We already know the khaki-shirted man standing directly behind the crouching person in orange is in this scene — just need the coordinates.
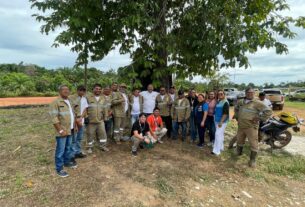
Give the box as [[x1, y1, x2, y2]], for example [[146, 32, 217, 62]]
[[156, 86, 173, 138]]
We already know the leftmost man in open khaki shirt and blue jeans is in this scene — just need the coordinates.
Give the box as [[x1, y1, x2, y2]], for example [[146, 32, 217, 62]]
[[49, 85, 79, 177]]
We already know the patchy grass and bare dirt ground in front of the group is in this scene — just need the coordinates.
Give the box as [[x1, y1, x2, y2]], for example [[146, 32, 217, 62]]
[[0, 108, 305, 207]]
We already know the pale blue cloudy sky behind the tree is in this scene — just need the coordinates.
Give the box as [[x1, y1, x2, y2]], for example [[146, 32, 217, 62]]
[[0, 0, 305, 84]]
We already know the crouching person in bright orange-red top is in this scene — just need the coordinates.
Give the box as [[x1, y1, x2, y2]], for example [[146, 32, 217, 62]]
[[147, 107, 167, 143]]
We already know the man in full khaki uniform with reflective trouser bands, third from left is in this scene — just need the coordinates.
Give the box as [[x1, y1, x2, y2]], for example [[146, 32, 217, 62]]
[[87, 84, 109, 153]]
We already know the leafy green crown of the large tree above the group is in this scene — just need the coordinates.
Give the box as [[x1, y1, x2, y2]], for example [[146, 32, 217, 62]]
[[30, 0, 305, 86]]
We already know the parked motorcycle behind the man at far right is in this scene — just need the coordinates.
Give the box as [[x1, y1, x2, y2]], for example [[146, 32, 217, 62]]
[[259, 112, 304, 149]]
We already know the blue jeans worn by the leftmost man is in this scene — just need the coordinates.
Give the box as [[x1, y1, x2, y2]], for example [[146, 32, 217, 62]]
[[55, 135, 73, 172]]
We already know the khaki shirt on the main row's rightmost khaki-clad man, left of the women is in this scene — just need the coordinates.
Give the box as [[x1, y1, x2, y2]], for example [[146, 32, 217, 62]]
[[171, 98, 191, 122]]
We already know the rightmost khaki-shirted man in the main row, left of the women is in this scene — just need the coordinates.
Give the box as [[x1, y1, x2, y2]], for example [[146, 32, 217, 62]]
[[171, 90, 191, 141]]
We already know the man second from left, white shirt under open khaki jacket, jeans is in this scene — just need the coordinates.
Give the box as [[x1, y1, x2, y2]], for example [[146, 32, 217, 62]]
[[69, 86, 88, 158]]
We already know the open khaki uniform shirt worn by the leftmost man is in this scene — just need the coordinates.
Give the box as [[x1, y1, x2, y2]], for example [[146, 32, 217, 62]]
[[49, 97, 77, 137]]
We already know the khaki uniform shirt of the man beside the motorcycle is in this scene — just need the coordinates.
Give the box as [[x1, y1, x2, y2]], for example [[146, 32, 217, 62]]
[[234, 99, 272, 129]]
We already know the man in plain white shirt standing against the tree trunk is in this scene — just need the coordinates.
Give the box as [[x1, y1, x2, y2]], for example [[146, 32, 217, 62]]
[[140, 84, 159, 116]]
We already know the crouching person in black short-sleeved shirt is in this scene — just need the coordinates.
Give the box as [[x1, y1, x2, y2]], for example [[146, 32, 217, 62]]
[[131, 113, 156, 156]]
